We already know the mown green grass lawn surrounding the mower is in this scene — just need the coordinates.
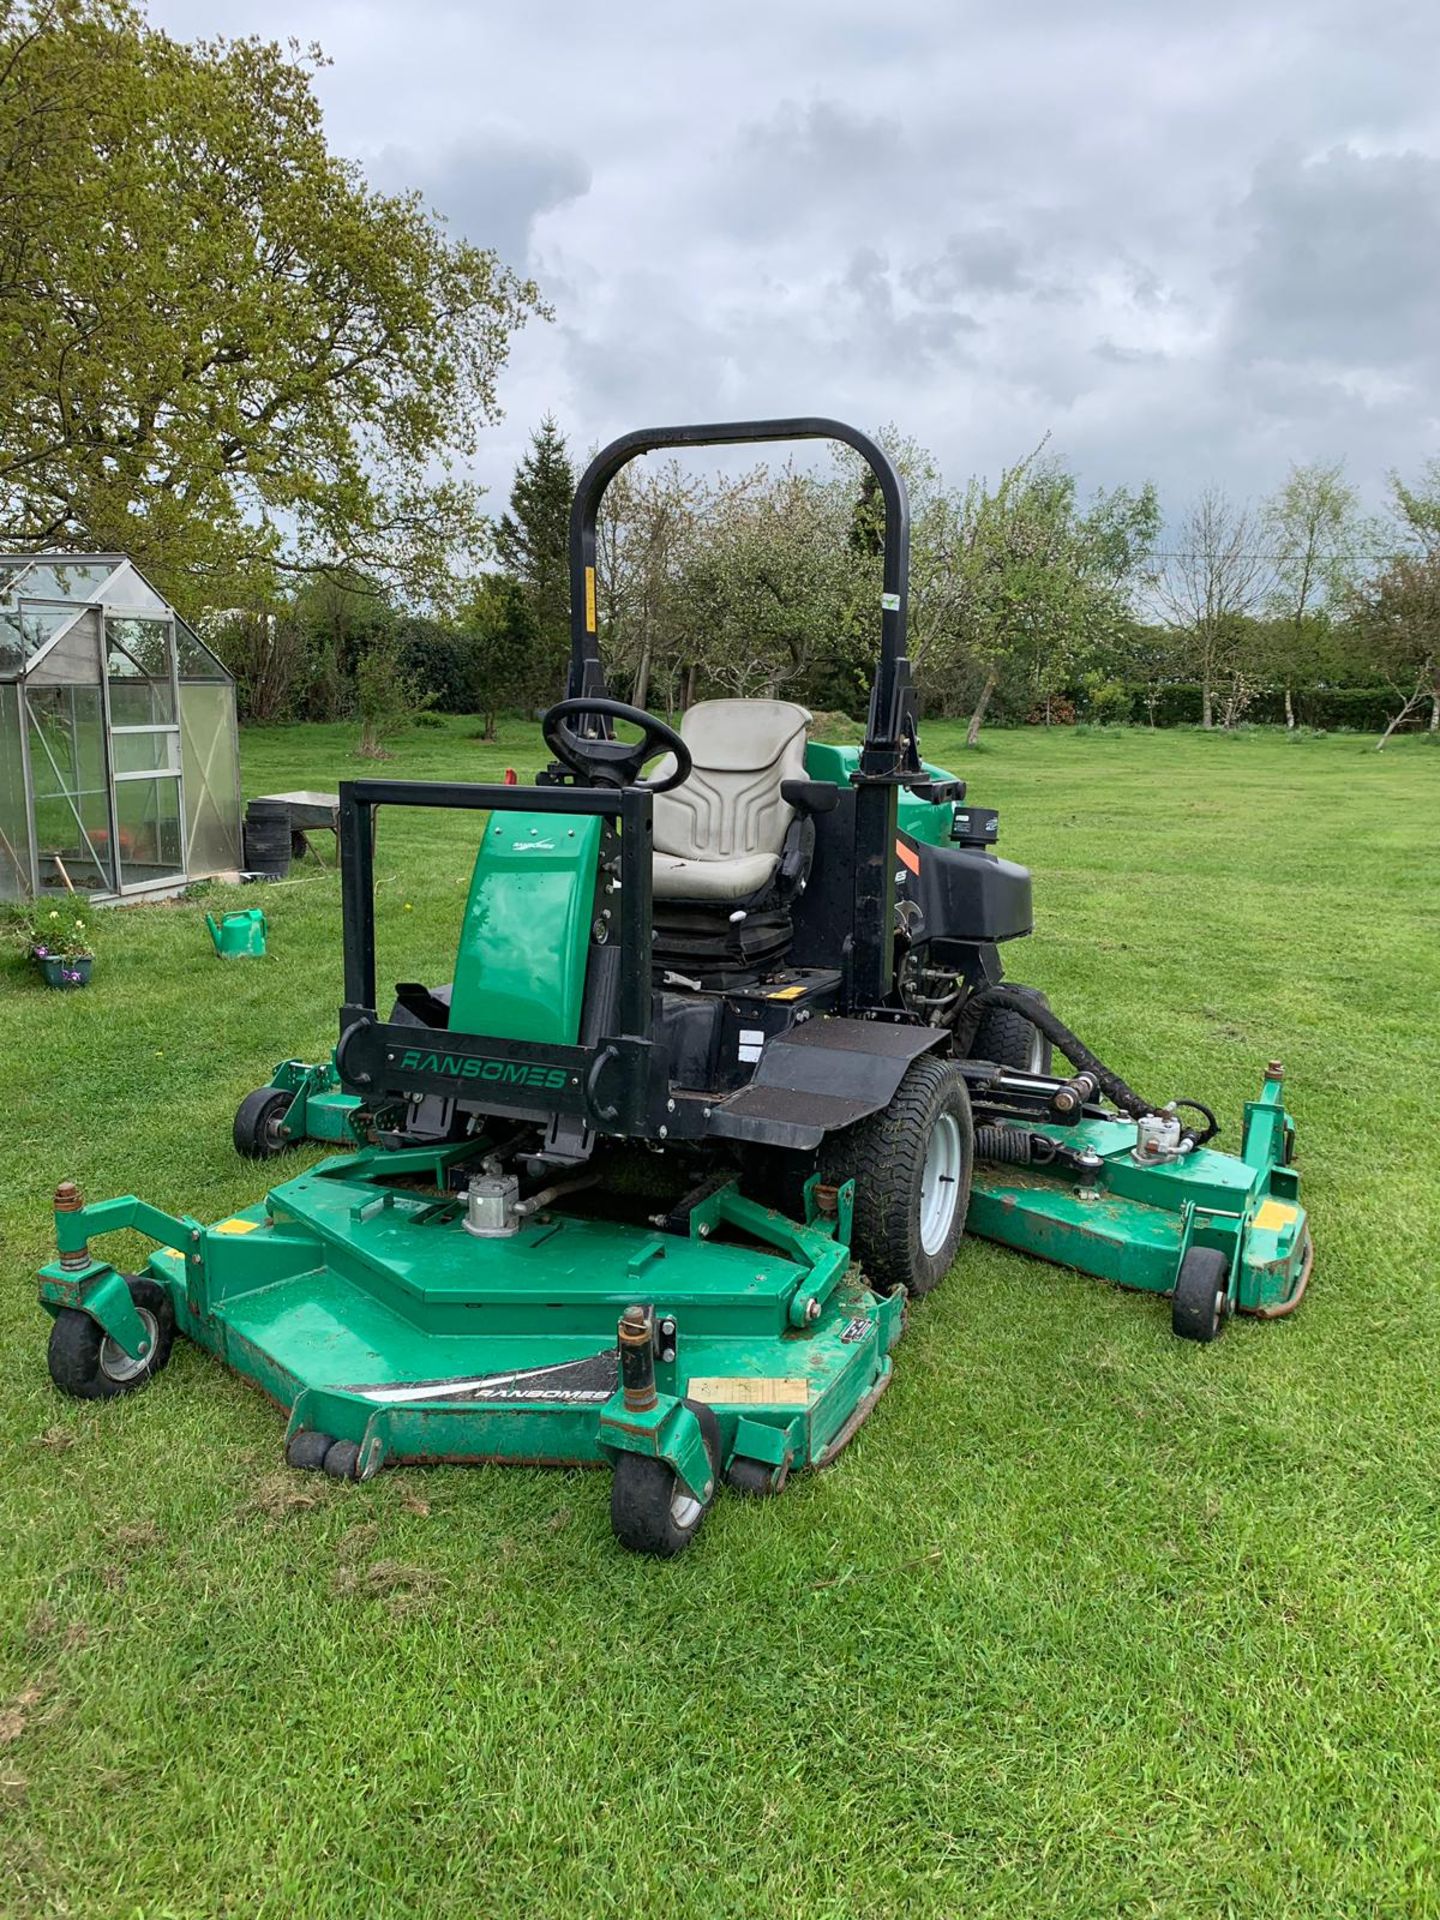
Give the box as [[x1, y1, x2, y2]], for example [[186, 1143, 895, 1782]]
[[0, 722, 1440, 1920]]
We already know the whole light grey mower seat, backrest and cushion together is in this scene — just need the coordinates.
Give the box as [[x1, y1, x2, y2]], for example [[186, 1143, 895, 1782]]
[[655, 701, 810, 900]]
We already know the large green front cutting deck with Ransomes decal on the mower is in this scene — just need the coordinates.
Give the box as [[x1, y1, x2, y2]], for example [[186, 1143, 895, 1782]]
[[40, 1148, 902, 1501]]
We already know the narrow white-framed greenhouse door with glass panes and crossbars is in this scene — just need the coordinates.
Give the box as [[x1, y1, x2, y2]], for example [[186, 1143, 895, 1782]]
[[106, 616, 186, 893]]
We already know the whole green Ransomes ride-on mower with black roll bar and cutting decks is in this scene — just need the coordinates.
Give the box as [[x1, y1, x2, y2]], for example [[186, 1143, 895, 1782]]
[[40, 419, 1309, 1555]]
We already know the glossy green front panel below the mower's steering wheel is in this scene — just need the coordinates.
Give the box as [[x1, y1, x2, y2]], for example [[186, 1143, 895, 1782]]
[[449, 812, 601, 1046]]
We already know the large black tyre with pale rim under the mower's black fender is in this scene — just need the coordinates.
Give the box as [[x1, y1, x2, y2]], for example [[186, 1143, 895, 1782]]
[[822, 1054, 975, 1294]]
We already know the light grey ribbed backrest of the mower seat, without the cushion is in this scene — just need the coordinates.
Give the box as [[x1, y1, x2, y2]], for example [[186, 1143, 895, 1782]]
[[655, 701, 810, 860]]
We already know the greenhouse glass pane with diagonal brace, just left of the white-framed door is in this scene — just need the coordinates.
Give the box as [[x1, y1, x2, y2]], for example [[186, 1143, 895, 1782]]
[[25, 687, 115, 893]]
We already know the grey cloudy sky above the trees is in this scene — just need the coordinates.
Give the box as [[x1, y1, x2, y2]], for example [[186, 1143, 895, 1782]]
[[150, 0, 1440, 513]]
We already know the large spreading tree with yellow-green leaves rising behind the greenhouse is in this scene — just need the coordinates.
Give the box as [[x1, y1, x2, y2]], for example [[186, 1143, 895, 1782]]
[[0, 0, 538, 605]]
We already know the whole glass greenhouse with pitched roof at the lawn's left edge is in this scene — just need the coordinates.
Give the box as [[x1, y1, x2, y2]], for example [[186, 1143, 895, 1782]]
[[0, 553, 240, 900]]
